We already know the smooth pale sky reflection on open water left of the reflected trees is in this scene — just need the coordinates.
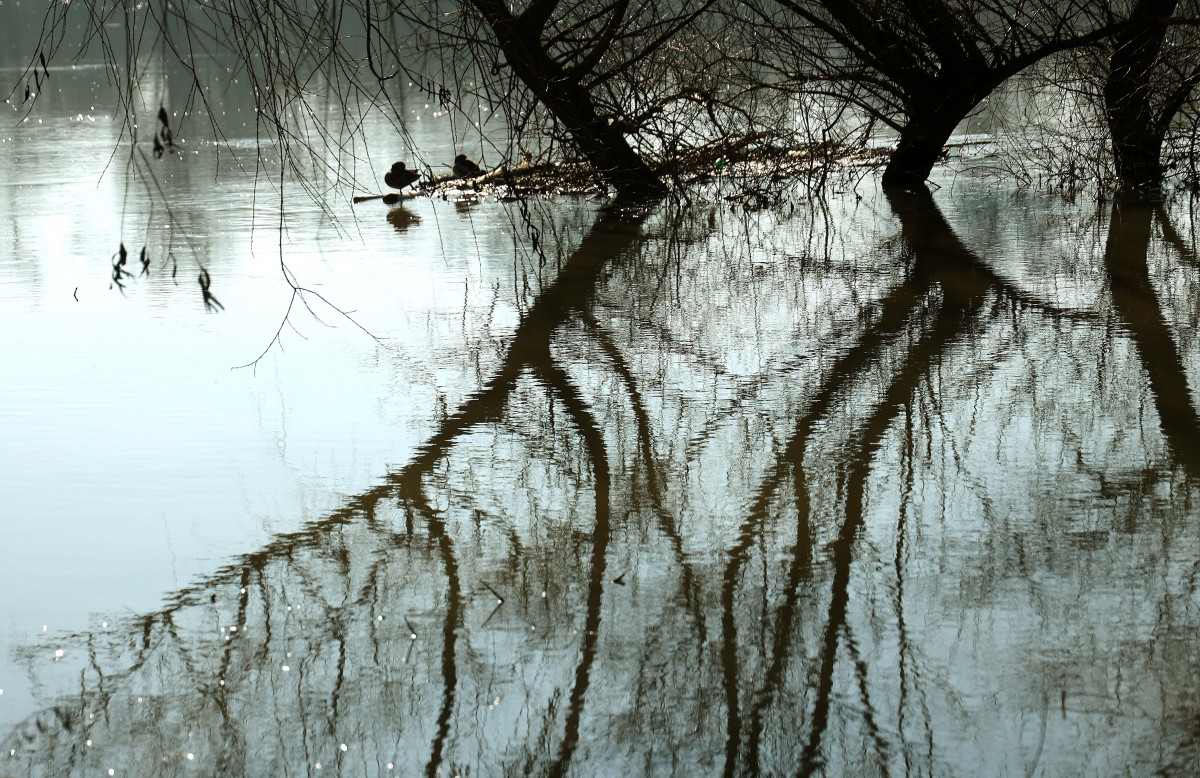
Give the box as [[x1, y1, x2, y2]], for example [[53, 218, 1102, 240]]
[[0, 60, 530, 730]]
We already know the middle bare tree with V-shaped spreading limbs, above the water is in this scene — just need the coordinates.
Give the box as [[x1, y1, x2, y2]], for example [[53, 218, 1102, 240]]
[[750, 0, 1147, 186]]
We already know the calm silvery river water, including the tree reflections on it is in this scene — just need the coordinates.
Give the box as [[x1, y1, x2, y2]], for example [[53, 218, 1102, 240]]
[[0, 47, 1200, 776]]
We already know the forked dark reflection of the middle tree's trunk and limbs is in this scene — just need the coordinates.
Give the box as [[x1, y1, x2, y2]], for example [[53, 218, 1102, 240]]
[[722, 187, 1099, 776]]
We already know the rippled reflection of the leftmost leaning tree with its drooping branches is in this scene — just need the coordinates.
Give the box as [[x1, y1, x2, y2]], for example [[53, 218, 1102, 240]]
[[2, 201, 690, 776]]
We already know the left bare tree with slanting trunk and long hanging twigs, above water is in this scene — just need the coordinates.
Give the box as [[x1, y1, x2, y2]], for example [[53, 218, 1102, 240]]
[[18, 0, 825, 198]]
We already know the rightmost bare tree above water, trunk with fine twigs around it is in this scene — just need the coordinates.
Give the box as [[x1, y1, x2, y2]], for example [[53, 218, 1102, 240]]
[[988, 0, 1200, 194]]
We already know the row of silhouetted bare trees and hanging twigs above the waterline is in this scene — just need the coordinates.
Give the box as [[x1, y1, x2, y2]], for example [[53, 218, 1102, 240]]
[[17, 0, 1200, 198]]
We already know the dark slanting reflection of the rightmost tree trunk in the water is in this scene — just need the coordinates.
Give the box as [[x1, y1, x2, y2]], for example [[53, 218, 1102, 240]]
[[1104, 202, 1200, 478]]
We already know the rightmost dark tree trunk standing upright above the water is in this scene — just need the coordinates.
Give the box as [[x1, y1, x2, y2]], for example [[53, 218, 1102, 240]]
[[1104, 0, 1177, 198]]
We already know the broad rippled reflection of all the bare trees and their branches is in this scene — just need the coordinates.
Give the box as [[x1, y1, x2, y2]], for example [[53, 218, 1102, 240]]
[[0, 184, 1200, 776]]
